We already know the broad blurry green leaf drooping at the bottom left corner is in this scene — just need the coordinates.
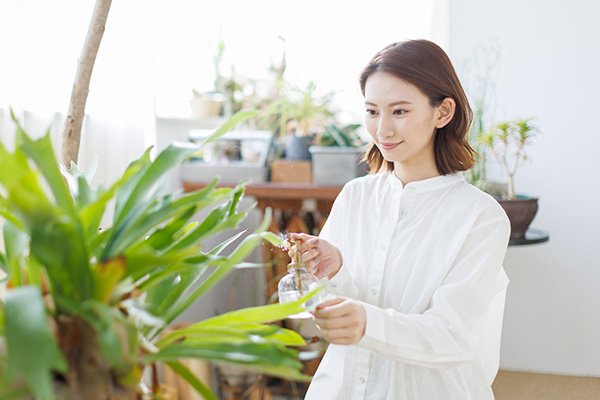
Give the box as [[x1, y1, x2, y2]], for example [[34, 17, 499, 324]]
[[5, 286, 67, 400]]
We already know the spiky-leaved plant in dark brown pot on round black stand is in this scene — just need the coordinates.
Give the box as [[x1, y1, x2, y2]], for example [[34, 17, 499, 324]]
[[479, 118, 539, 239]]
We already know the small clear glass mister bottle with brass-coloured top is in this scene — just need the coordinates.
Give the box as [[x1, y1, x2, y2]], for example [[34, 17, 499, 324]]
[[278, 241, 325, 318]]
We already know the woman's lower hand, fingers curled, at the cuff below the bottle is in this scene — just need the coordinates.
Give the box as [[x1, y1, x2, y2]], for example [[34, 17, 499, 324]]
[[313, 297, 367, 344]]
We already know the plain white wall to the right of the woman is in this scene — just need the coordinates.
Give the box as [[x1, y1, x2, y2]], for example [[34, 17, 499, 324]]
[[450, 0, 600, 376]]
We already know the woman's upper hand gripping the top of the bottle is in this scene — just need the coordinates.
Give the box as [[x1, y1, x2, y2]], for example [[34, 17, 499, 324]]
[[288, 233, 342, 279]]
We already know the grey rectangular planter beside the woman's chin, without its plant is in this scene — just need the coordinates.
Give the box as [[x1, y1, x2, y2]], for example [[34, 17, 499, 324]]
[[309, 146, 367, 186]]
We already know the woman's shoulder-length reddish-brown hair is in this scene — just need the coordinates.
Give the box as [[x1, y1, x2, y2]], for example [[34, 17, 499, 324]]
[[360, 40, 477, 175]]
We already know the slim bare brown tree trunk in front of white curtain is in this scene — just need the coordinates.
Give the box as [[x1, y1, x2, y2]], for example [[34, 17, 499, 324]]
[[60, 0, 112, 168]]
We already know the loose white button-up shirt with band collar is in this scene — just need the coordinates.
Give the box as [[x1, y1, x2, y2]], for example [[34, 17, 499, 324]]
[[306, 172, 510, 400]]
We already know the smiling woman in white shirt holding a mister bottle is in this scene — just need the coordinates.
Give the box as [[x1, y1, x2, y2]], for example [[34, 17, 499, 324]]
[[293, 40, 510, 400]]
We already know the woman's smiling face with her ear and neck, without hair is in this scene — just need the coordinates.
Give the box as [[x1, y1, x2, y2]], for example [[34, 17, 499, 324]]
[[365, 72, 445, 177]]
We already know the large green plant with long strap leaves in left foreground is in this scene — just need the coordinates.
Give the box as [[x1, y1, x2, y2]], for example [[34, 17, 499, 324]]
[[0, 112, 316, 400]]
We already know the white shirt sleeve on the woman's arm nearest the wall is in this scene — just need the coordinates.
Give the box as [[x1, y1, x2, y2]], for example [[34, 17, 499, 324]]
[[357, 215, 510, 367]]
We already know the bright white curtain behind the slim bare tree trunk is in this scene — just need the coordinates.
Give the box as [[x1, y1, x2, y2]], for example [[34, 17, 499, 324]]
[[0, 0, 155, 185]]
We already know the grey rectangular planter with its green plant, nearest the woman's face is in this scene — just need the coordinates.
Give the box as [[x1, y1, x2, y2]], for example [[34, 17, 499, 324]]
[[309, 123, 367, 185]]
